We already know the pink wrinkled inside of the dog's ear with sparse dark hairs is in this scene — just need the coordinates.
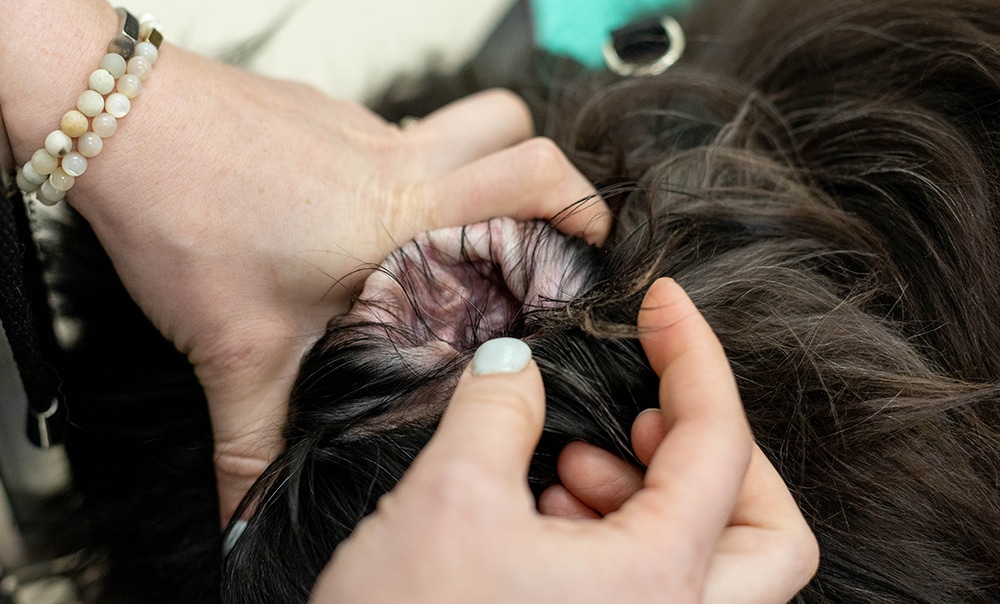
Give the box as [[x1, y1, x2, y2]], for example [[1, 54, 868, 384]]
[[351, 218, 593, 351]]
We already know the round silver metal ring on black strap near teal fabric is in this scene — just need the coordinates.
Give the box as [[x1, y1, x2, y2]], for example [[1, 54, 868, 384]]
[[604, 17, 687, 77]]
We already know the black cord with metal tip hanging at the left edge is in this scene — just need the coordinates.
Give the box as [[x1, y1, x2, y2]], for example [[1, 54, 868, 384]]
[[0, 177, 65, 448]]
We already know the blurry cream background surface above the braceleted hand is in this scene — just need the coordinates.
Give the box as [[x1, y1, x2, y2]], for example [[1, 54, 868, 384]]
[[142, 0, 513, 99]]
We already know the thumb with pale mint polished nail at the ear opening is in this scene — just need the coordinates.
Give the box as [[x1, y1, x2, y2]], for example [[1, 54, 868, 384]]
[[420, 338, 545, 485]]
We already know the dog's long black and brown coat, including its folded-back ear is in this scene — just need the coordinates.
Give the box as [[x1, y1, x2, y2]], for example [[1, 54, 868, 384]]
[[222, 0, 1000, 603]]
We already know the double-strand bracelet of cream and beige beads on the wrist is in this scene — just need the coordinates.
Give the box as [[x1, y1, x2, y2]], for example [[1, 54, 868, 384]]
[[17, 8, 163, 205]]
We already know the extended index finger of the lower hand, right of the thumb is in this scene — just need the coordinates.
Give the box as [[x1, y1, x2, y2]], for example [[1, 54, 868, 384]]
[[622, 279, 753, 552]]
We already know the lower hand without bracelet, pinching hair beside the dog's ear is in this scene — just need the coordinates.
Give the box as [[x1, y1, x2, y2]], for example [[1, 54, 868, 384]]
[[313, 280, 818, 604]]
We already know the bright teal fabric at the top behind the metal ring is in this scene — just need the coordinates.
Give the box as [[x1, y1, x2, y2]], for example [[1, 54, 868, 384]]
[[531, 0, 692, 67]]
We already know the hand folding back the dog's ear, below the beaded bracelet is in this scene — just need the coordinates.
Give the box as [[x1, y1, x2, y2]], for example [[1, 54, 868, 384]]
[[101, 55, 609, 520]]
